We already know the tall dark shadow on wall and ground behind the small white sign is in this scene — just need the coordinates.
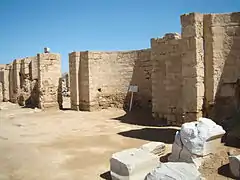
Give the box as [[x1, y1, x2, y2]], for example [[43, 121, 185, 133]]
[[111, 49, 157, 126]]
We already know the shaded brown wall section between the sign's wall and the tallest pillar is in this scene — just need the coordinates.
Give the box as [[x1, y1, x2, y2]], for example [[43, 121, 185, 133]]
[[151, 34, 182, 124]]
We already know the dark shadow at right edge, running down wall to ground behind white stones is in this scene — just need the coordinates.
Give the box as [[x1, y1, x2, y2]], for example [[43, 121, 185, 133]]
[[206, 13, 240, 147]]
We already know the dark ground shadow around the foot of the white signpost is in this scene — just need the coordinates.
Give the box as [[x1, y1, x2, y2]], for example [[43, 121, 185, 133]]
[[112, 109, 171, 127]]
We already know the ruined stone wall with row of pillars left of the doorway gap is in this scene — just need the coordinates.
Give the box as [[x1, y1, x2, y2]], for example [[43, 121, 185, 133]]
[[0, 53, 61, 109]]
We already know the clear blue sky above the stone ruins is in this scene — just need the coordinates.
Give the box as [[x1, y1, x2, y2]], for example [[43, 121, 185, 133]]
[[0, 0, 240, 72]]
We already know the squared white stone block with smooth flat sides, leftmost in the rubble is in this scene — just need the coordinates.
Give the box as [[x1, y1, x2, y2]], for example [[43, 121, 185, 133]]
[[110, 148, 160, 180]]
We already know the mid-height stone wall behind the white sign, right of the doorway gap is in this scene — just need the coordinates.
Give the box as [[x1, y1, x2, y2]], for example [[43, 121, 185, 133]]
[[69, 49, 152, 110]]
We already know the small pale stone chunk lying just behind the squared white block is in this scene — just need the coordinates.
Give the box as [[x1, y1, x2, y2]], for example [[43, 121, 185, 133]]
[[140, 142, 166, 156]]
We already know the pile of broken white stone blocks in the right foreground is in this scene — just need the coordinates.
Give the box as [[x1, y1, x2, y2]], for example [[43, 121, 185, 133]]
[[110, 118, 228, 180]]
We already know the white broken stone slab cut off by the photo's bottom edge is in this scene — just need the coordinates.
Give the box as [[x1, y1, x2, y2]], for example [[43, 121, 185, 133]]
[[145, 162, 202, 180]]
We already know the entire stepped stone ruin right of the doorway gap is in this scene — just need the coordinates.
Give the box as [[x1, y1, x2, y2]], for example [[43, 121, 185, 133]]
[[69, 13, 240, 125]]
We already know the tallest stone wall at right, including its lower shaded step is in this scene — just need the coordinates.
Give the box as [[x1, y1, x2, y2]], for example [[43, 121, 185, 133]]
[[151, 13, 240, 124]]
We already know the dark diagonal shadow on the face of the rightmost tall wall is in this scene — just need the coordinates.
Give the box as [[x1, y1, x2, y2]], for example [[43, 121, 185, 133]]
[[207, 13, 240, 123]]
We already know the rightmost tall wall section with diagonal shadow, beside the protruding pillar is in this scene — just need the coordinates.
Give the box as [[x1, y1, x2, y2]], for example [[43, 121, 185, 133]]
[[204, 13, 240, 121]]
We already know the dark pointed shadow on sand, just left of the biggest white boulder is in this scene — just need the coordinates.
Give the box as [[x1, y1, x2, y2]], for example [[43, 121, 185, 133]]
[[118, 128, 177, 144]]
